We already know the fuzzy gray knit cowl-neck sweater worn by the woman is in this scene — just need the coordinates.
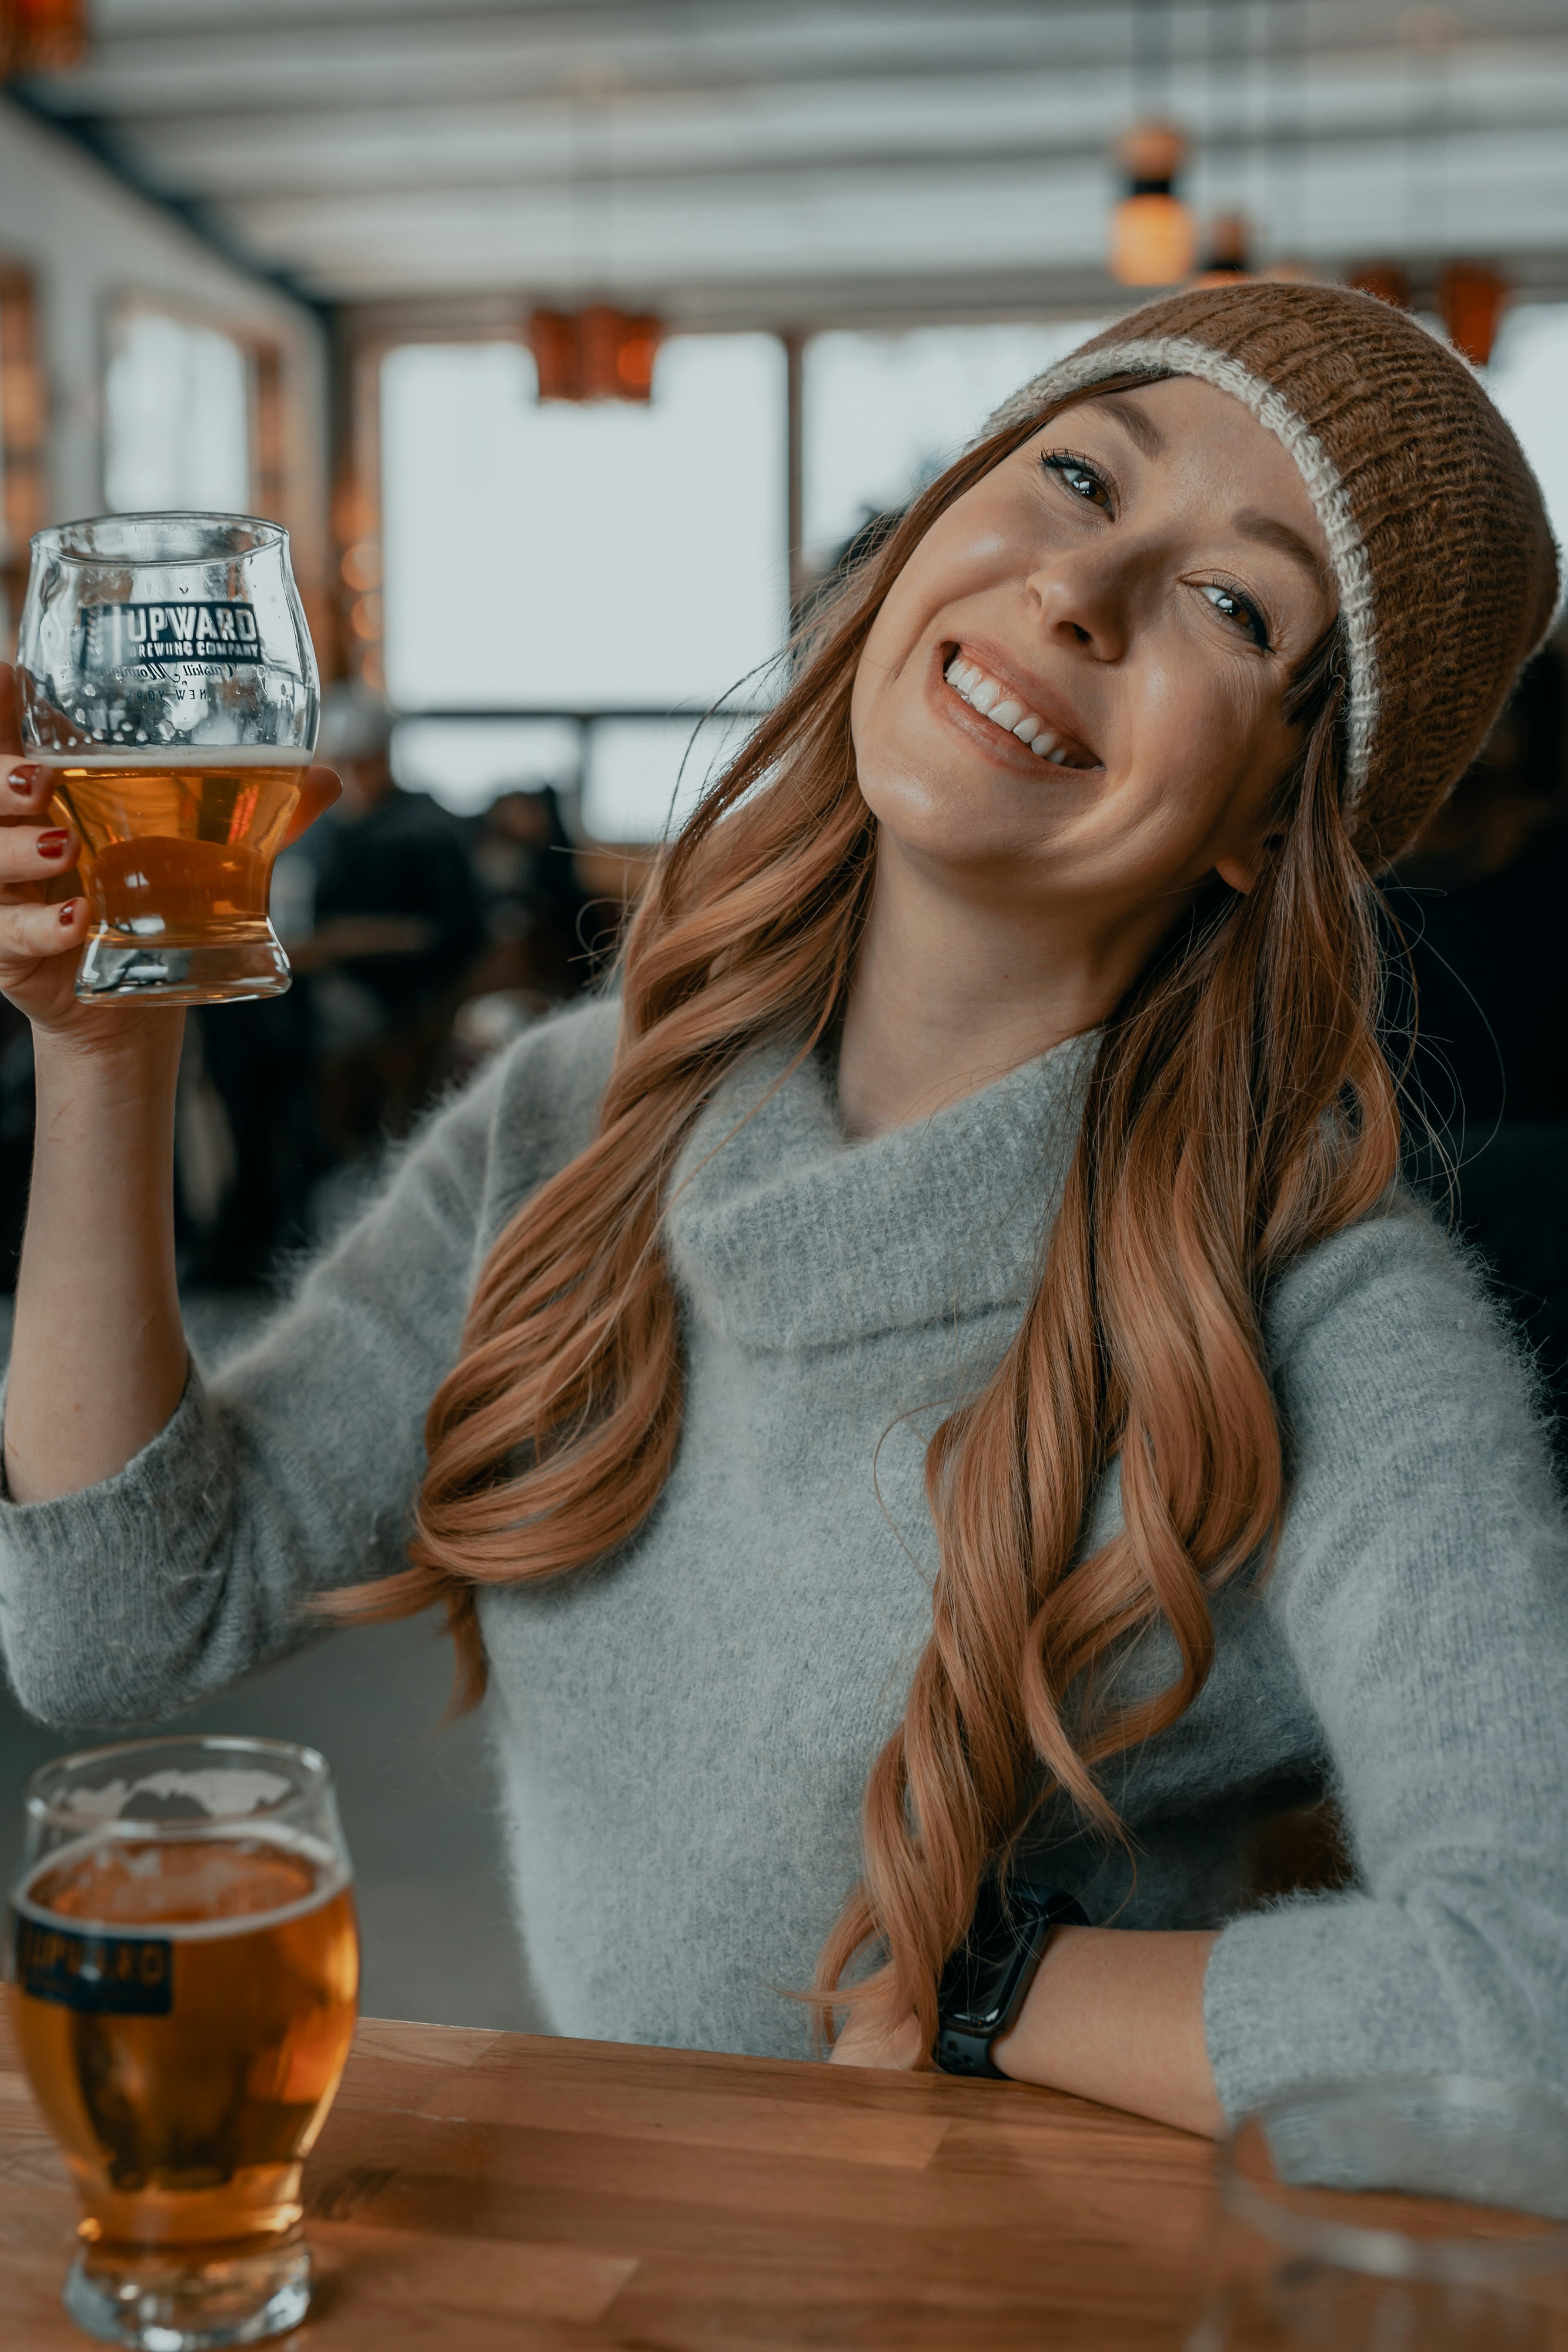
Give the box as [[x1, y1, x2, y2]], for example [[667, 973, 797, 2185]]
[[0, 1007, 1568, 2112]]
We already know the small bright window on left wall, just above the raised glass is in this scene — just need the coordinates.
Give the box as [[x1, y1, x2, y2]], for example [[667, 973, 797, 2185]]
[[103, 308, 252, 513]]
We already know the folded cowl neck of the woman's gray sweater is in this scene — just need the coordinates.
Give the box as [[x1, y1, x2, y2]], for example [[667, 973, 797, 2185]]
[[666, 1030, 1098, 1348]]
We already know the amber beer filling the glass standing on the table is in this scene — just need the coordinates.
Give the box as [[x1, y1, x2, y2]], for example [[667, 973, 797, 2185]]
[[9, 1825, 360, 2263]]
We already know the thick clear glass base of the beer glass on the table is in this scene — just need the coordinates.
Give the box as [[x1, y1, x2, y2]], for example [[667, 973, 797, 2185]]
[[63, 2230, 310, 2352]]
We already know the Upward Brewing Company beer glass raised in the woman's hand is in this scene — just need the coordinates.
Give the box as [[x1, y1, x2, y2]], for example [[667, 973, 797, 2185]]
[[16, 515, 320, 1004]]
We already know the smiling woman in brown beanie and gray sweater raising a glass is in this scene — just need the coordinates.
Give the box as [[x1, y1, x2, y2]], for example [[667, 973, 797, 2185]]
[[0, 287, 1568, 2131]]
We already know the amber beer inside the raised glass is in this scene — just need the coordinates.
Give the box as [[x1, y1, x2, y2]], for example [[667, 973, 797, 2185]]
[[54, 748, 306, 950]]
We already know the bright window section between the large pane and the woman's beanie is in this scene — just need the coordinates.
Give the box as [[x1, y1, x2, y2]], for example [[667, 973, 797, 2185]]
[[801, 320, 1093, 572]]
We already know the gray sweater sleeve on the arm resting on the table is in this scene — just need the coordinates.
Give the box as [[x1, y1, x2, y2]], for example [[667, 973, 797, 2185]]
[[1203, 1209, 1568, 2117]]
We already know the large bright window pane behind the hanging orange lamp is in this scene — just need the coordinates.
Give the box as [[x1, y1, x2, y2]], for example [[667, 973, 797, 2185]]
[[381, 334, 787, 715]]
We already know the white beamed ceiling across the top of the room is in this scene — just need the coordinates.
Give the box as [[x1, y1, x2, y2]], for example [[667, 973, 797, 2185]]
[[21, 0, 1568, 325]]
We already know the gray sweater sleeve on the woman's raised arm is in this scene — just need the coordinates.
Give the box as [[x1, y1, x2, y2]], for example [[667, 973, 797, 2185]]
[[0, 1007, 607, 1726]]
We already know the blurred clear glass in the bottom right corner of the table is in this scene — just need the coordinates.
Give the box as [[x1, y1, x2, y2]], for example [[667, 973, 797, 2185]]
[[1187, 2074, 1568, 2352]]
